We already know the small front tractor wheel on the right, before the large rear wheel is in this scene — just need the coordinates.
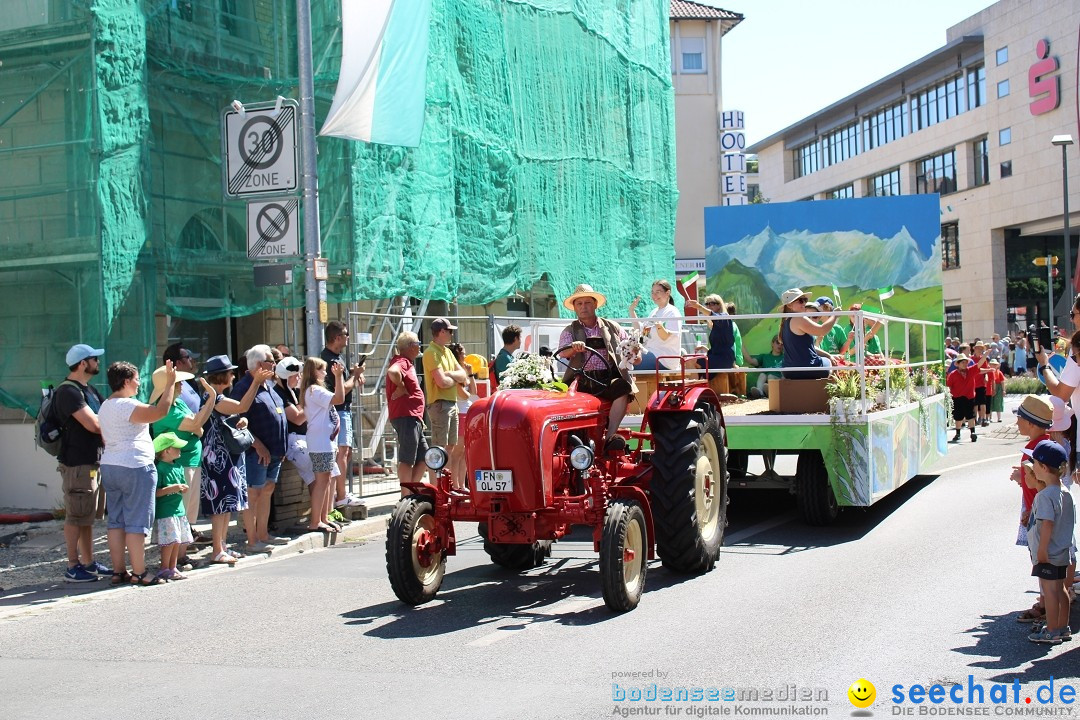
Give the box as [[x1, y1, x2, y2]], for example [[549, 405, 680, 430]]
[[600, 500, 649, 612]]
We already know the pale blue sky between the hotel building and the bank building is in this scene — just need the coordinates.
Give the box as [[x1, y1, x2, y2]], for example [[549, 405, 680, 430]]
[[712, 0, 994, 146]]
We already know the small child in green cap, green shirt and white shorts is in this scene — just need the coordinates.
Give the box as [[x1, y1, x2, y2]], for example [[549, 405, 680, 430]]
[[153, 432, 191, 582]]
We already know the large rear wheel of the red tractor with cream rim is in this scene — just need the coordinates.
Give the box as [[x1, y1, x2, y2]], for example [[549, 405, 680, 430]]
[[649, 403, 728, 572]]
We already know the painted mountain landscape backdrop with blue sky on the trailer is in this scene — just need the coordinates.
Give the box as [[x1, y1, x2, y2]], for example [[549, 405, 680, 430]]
[[705, 195, 944, 359]]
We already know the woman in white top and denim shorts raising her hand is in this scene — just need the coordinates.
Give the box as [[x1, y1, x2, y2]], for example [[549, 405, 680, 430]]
[[97, 361, 176, 585]]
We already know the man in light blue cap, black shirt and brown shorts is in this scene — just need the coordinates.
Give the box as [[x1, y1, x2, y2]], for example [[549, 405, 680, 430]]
[[50, 344, 111, 583]]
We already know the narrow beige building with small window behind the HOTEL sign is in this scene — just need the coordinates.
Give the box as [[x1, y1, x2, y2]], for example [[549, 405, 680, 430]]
[[671, 0, 743, 269]]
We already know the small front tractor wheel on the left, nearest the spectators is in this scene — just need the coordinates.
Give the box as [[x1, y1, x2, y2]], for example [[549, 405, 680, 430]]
[[387, 495, 446, 606]]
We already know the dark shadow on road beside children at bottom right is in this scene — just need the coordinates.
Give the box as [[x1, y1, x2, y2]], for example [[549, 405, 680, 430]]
[[954, 603, 1080, 683]]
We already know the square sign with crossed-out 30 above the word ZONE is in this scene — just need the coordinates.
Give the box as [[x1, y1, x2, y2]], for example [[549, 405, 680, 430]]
[[221, 100, 298, 198]]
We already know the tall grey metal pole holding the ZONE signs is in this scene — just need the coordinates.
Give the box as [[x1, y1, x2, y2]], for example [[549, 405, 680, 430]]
[[296, 0, 326, 357]]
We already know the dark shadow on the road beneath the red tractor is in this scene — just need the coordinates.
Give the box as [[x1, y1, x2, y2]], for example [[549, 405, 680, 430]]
[[341, 528, 712, 640]]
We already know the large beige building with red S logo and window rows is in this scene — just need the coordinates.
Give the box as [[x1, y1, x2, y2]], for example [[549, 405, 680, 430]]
[[748, 0, 1080, 339]]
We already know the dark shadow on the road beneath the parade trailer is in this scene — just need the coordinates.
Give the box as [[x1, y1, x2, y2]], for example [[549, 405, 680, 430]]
[[724, 475, 939, 555]]
